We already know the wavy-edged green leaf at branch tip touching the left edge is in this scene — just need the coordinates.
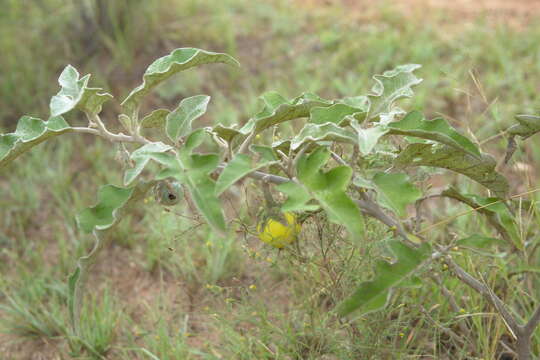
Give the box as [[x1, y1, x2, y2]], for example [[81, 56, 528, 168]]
[[0, 116, 72, 169]]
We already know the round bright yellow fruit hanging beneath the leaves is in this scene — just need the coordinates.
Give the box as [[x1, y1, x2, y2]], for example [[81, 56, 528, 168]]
[[257, 212, 301, 249]]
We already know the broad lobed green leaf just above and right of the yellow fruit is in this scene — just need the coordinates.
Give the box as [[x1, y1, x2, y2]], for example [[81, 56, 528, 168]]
[[297, 147, 364, 238]]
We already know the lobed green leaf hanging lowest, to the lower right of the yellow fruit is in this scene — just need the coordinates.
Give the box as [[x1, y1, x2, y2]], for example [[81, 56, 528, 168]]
[[337, 240, 431, 316]]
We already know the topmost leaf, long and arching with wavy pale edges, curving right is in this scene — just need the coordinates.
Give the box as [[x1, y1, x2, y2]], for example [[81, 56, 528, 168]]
[[121, 48, 240, 115]]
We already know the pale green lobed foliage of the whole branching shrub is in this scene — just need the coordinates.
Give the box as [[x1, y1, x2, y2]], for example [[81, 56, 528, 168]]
[[0, 42, 538, 352]]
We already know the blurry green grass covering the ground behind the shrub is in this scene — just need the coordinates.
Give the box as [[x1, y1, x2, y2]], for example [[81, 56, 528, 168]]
[[0, 0, 540, 360]]
